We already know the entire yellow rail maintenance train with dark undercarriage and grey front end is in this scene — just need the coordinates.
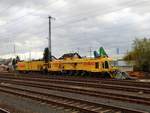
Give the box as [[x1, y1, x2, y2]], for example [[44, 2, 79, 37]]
[[16, 47, 130, 79]]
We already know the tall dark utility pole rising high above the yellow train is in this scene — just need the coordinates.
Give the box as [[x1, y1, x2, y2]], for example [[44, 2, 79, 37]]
[[48, 16, 55, 61]]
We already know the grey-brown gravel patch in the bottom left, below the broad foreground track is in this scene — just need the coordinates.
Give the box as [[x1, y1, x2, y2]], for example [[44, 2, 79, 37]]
[[0, 92, 78, 113]]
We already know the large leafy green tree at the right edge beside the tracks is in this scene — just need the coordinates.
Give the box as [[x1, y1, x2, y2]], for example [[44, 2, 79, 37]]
[[124, 38, 150, 72]]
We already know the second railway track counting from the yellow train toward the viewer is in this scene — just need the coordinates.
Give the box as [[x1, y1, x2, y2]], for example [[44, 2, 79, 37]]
[[0, 76, 150, 93]]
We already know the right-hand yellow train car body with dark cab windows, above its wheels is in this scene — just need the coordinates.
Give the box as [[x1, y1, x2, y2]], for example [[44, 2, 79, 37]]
[[60, 58, 112, 72]]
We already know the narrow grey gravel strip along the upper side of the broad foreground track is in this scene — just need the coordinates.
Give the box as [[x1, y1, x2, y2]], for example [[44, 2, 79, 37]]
[[1, 85, 150, 113]]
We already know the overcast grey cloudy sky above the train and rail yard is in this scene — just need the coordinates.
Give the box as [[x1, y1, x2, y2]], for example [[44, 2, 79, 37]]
[[0, 0, 150, 58]]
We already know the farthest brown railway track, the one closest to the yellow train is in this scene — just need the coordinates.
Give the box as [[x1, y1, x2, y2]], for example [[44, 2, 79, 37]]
[[0, 73, 150, 87]]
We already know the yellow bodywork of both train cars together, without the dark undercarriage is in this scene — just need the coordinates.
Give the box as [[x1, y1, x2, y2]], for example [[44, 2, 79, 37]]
[[17, 57, 116, 73]]
